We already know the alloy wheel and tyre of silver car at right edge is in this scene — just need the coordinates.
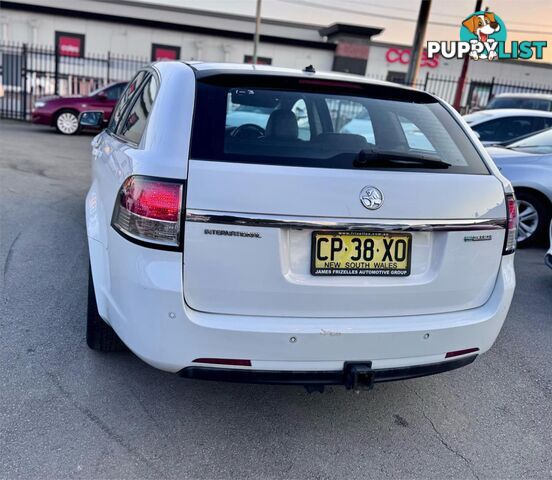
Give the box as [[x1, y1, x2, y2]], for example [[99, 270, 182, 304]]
[[516, 190, 550, 247]]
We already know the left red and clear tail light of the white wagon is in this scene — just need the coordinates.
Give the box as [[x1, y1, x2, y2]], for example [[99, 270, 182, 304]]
[[111, 176, 184, 248]]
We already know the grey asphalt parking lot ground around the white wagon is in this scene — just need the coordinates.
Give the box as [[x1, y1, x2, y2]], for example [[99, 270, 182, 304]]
[[0, 117, 552, 479]]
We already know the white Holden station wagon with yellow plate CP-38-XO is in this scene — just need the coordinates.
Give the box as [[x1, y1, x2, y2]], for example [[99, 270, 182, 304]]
[[81, 62, 517, 389]]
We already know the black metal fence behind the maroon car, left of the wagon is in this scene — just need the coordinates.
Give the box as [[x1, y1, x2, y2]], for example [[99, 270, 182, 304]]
[[0, 43, 148, 120]]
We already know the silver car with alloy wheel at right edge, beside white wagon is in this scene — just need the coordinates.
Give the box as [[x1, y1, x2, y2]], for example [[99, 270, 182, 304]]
[[488, 129, 552, 244]]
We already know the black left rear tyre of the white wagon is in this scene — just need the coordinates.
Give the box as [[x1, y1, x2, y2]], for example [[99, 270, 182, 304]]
[[86, 267, 128, 352]]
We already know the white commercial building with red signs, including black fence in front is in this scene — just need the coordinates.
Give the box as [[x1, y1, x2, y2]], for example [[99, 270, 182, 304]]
[[0, 0, 552, 118]]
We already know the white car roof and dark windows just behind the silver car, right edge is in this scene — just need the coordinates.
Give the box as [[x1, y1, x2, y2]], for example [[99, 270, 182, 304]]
[[464, 108, 552, 145]]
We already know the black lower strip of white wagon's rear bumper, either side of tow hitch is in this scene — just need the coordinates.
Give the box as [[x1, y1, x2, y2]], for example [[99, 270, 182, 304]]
[[178, 355, 477, 388]]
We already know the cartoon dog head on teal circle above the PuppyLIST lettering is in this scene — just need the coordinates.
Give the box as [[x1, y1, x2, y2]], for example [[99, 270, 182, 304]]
[[460, 11, 506, 60]]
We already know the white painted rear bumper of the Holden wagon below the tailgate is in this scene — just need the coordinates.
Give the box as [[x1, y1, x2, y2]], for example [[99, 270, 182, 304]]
[[87, 216, 515, 376]]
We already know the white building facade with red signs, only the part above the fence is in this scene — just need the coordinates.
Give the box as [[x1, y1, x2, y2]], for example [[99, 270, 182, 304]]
[[4, 0, 552, 84]]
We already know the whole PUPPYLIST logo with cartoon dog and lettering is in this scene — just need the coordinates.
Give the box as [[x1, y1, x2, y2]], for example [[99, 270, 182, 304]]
[[427, 10, 547, 61]]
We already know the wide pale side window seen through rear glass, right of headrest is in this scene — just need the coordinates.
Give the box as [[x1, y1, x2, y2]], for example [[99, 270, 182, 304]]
[[326, 98, 376, 143]]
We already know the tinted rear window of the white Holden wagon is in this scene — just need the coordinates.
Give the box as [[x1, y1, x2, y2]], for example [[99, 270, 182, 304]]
[[191, 75, 488, 174]]
